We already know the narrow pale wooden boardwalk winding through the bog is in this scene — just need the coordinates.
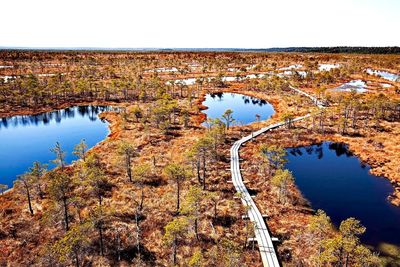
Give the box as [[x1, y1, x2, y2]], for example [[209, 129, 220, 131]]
[[231, 86, 324, 267]]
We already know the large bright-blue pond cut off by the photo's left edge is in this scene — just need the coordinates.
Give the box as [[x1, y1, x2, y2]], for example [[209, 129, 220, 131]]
[[0, 106, 110, 187]]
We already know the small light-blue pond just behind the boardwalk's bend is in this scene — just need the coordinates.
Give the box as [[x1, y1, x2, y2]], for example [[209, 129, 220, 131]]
[[202, 93, 275, 124]]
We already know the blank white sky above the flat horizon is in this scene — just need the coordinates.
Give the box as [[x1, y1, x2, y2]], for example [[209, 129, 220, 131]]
[[0, 0, 400, 48]]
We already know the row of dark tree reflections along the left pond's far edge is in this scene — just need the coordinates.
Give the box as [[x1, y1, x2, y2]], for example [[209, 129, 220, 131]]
[[0, 106, 113, 129]]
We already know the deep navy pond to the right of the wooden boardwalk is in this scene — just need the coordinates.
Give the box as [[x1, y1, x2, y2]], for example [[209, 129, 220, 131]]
[[286, 142, 400, 246]]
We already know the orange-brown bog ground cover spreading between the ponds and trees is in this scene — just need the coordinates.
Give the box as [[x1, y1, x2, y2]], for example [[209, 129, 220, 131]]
[[0, 51, 400, 266]]
